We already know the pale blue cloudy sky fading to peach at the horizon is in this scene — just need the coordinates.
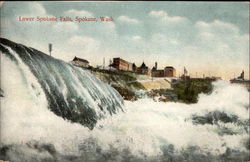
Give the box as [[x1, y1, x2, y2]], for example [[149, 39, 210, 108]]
[[1, 1, 249, 80]]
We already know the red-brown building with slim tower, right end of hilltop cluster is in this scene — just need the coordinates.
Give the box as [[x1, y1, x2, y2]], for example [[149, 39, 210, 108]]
[[151, 62, 176, 77]]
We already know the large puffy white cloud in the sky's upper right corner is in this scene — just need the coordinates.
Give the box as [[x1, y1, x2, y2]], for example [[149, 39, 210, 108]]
[[194, 20, 244, 52]]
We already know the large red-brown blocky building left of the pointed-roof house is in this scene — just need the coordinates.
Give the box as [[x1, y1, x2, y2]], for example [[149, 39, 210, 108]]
[[110, 57, 133, 71]]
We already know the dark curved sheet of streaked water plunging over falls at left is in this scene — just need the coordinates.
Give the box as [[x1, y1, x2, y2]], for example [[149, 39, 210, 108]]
[[0, 38, 123, 129]]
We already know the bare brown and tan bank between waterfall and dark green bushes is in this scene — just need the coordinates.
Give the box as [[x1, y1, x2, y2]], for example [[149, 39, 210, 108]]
[[84, 68, 174, 100]]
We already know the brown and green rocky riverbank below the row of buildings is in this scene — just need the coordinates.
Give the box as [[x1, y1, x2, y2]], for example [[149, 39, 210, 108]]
[[82, 67, 212, 103]]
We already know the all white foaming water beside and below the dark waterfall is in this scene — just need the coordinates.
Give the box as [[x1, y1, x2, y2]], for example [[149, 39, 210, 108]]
[[0, 38, 249, 161]]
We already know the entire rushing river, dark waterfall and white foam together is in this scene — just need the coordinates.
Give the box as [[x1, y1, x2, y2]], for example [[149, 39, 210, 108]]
[[0, 39, 250, 162]]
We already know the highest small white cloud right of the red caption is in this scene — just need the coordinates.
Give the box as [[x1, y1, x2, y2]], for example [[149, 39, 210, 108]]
[[148, 10, 187, 22]]
